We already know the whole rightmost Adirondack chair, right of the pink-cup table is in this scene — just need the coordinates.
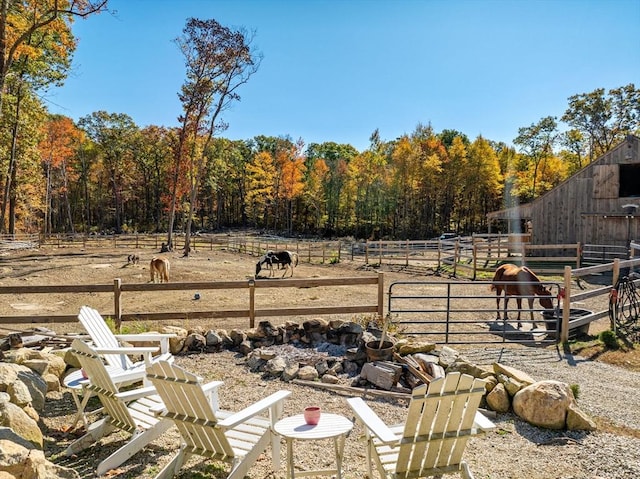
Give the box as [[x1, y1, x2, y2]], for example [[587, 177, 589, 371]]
[[347, 372, 495, 479]]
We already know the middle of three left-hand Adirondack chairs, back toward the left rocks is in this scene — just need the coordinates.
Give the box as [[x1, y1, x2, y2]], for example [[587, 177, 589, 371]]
[[65, 339, 173, 476]]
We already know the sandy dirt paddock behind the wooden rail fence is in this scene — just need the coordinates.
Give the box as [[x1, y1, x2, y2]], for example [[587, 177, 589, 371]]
[[0, 246, 606, 334]]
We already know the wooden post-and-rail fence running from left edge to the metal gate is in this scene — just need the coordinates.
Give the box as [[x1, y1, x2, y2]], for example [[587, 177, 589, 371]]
[[0, 273, 384, 328]]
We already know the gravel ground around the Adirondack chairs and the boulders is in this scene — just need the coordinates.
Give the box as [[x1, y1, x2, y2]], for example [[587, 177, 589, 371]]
[[42, 348, 640, 479]]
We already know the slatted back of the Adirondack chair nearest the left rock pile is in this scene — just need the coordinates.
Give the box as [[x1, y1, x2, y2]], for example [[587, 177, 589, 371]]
[[71, 339, 136, 433]]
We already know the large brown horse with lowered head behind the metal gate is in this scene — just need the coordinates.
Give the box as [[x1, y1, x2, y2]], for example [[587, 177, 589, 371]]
[[491, 264, 553, 329]]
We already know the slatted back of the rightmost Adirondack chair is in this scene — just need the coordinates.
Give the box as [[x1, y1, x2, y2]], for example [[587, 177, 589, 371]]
[[396, 373, 485, 477]]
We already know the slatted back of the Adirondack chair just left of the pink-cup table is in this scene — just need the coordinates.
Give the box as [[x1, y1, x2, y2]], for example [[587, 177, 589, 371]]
[[147, 361, 234, 458]]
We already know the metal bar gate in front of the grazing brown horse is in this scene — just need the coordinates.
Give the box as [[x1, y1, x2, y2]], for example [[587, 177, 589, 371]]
[[387, 281, 562, 346]]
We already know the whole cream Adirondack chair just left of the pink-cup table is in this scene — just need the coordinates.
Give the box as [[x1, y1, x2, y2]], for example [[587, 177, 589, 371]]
[[147, 361, 291, 479]]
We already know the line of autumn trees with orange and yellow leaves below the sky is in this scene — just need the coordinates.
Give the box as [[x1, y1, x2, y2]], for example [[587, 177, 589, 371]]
[[0, 0, 640, 245]]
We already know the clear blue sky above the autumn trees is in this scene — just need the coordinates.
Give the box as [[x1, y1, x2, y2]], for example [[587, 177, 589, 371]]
[[46, 0, 640, 151]]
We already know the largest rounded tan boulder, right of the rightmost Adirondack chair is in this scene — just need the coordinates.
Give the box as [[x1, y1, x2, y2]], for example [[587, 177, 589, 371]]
[[512, 380, 575, 429]]
